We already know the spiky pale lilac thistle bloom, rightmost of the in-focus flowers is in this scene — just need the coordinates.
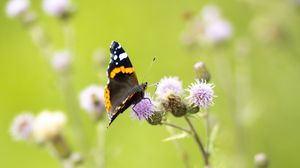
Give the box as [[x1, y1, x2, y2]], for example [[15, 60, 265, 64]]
[[187, 80, 214, 109]]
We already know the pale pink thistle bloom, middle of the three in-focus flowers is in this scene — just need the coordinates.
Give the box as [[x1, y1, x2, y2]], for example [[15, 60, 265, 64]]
[[155, 77, 183, 98]]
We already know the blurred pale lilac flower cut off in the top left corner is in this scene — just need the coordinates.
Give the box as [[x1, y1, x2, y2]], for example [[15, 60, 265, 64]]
[[6, 0, 30, 17]]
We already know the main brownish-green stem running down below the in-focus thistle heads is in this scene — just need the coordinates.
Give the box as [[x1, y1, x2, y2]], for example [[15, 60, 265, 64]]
[[184, 116, 209, 166]]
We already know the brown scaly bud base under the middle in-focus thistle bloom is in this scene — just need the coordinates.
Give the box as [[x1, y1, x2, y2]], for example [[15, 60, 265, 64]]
[[161, 90, 187, 117]]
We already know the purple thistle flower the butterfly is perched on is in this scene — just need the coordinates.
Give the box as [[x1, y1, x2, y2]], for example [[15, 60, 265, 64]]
[[132, 96, 155, 120]]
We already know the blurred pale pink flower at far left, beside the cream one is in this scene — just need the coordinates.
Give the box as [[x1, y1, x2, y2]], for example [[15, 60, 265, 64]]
[[10, 112, 34, 140]]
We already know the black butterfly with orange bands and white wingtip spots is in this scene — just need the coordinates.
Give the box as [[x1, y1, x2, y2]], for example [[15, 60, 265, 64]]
[[104, 41, 147, 125]]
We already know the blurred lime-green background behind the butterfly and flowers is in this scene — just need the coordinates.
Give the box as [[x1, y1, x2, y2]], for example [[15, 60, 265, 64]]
[[0, 0, 300, 168]]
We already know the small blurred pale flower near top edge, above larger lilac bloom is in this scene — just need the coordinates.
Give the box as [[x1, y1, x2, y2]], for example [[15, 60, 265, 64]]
[[201, 4, 221, 22]]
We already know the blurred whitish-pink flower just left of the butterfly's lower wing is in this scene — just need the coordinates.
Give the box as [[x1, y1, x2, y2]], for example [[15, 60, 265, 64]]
[[79, 85, 104, 116]]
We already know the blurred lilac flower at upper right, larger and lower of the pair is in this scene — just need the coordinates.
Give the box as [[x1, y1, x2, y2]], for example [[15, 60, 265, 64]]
[[204, 19, 232, 44]]
